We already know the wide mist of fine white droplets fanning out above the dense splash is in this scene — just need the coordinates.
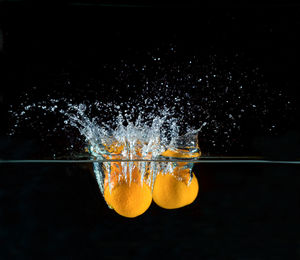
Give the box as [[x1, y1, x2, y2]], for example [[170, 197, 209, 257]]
[[6, 45, 292, 155]]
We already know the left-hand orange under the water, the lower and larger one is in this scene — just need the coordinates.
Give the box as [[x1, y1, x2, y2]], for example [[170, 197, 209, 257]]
[[104, 163, 152, 218]]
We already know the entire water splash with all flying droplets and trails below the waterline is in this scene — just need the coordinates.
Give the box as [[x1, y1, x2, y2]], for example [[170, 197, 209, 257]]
[[10, 44, 292, 196]]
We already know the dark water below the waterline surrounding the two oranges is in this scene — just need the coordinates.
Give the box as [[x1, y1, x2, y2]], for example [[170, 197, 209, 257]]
[[0, 163, 300, 259]]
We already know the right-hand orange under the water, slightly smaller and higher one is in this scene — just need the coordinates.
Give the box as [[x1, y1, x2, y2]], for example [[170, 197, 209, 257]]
[[152, 170, 199, 209]]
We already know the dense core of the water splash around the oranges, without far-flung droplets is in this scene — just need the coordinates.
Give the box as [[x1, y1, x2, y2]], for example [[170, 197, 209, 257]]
[[61, 100, 206, 193]]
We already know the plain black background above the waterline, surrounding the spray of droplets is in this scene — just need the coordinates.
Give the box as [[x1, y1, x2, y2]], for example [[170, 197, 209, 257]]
[[0, 1, 300, 159]]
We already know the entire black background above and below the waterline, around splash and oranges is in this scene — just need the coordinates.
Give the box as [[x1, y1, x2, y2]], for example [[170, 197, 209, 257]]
[[0, 1, 300, 260]]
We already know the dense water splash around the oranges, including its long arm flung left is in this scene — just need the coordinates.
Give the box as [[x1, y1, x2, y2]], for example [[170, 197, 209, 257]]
[[7, 92, 207, 196]]
